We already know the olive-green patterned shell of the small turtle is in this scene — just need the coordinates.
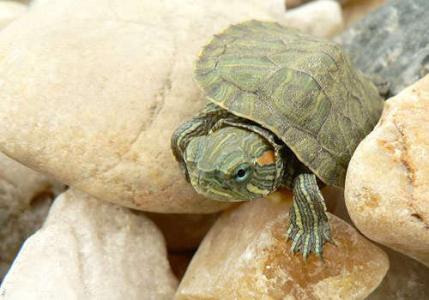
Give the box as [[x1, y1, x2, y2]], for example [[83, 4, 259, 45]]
[[195, 21, 383, 187]]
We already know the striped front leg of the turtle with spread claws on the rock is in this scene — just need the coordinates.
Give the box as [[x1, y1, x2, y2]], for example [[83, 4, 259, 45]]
[[287, 174, 332, 259]]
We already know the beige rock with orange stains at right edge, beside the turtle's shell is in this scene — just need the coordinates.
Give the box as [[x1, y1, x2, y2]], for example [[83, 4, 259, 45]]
[[345, 76, 429, 266]]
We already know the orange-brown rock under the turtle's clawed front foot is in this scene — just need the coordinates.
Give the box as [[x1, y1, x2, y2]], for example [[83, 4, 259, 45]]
[[176, 193, 389, 300]]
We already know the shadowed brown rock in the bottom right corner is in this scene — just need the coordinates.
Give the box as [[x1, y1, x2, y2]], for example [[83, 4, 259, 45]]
[[367, 248, 429, 300]]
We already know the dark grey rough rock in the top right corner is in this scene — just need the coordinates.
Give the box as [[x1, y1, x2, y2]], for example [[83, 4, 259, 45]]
[[341, 0, 429, 95]]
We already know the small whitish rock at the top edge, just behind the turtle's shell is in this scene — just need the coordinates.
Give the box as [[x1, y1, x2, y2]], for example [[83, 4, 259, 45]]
[[285, 0, 343, 37]]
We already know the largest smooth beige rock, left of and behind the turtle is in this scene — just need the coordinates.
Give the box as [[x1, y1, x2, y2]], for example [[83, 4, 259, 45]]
[[0, 0, 290, 213]]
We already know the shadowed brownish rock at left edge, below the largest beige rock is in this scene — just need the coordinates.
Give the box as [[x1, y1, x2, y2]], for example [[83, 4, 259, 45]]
[[0, 153, 64, 282]]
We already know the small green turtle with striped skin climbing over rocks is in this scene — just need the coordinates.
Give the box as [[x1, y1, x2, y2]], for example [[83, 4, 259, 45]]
[[171, 20, 384, 259]]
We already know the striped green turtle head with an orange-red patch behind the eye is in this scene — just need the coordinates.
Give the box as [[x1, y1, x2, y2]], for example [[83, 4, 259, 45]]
[[184, 127, 279, 202]]
